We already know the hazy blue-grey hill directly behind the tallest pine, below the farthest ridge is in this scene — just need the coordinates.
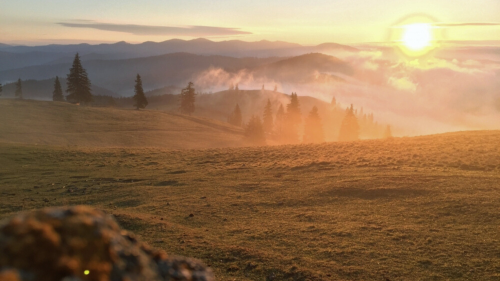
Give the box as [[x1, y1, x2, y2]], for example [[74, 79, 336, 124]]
[[0, 53, 280, 95]]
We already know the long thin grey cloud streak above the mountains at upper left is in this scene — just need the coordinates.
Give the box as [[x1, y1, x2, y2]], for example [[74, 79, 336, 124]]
[[57, 20, 252, 37]]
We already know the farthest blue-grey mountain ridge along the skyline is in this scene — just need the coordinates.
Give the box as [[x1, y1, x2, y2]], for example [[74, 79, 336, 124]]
[[0, 38, 358, 70]]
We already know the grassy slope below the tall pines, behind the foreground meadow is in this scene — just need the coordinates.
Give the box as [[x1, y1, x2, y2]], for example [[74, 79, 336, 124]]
[[0, 99, 243, 149]]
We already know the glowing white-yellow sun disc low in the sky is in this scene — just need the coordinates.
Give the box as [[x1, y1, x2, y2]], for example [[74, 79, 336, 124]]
[[402, 23, 432, 51]]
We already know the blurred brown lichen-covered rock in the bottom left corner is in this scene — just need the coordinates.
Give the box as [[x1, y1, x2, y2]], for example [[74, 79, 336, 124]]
[[0, 203, 214, 281]]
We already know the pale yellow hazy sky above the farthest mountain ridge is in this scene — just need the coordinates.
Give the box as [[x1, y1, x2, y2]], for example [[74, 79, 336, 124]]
[[0, 0, 500, 45]]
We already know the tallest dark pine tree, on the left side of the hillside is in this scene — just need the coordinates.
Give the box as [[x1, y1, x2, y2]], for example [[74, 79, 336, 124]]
[[66, 53, 92, 103]]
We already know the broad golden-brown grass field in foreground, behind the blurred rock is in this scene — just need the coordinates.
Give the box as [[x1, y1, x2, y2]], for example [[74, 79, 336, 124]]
[[0, 131, 500, 280]]
